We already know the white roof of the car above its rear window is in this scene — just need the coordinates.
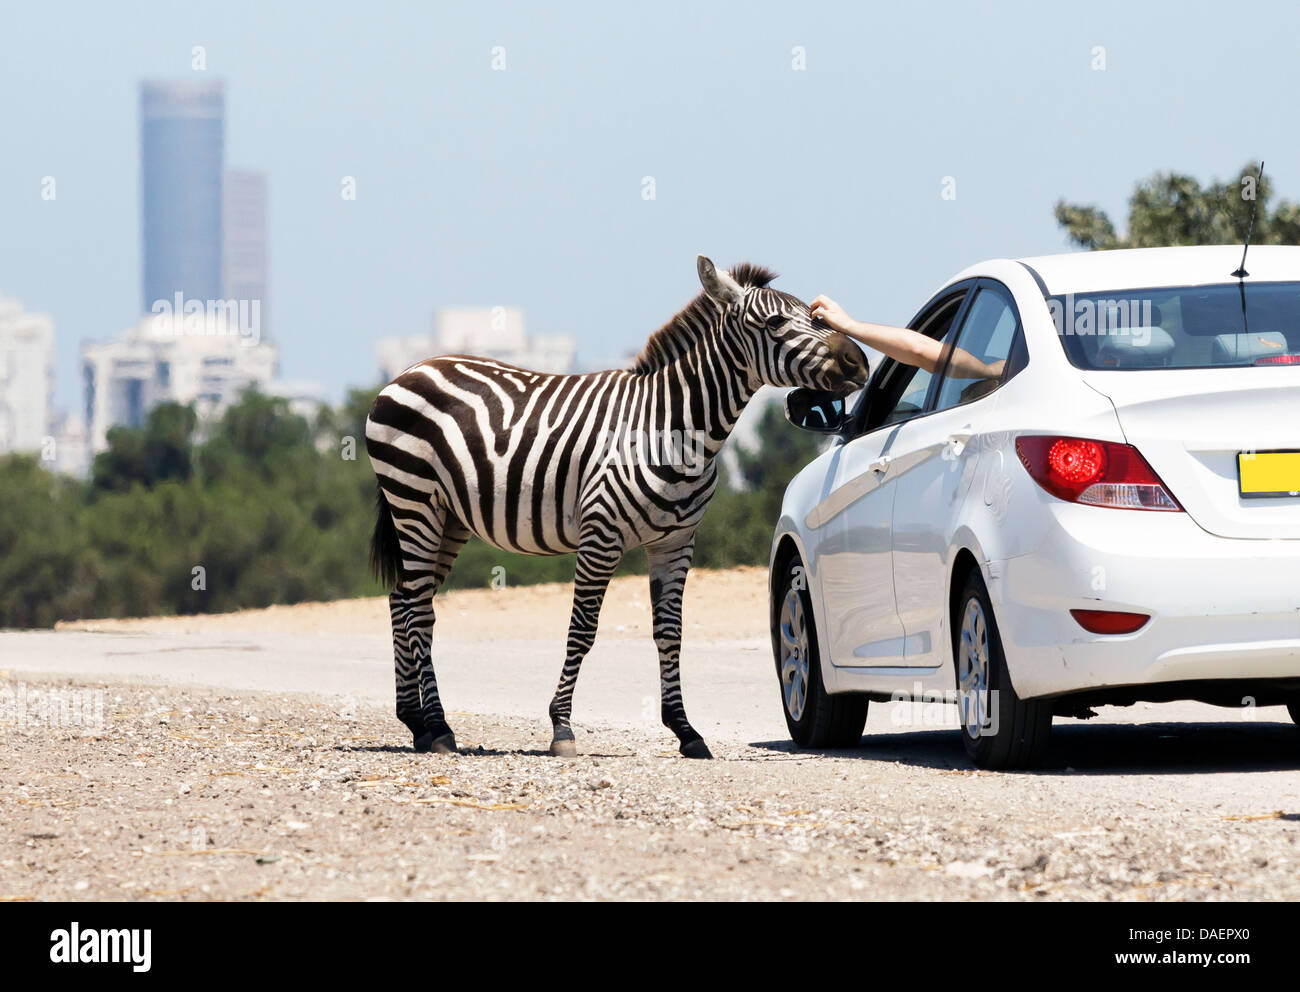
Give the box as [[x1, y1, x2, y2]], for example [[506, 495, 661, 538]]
[[1018, 244, 1300, 295]]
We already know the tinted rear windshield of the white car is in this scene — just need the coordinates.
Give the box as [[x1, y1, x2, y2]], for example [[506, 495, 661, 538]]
[[1047, 281, 1300, 369]]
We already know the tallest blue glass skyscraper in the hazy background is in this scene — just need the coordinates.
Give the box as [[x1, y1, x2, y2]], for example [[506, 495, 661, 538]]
[[140, 82, 225, 313]]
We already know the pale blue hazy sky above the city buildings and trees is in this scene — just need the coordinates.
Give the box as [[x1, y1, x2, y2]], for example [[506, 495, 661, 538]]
[[0, 0, 1300, 408]]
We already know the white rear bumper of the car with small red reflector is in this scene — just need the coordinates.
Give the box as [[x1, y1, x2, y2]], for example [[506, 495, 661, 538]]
[[988, 503, 1300, 698]]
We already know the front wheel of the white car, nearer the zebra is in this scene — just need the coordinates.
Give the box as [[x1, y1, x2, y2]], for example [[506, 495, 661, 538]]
[[772, 558, 867, 748]]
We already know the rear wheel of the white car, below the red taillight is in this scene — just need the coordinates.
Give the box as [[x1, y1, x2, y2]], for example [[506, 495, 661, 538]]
[[953, 568, 1052, 768]]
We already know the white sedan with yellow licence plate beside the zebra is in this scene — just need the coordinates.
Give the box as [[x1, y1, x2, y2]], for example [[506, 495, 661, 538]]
[[771, 246, 1300, 767]]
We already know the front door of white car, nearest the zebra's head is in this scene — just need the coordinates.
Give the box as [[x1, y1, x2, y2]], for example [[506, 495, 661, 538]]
[[809, 285, 969, 667]]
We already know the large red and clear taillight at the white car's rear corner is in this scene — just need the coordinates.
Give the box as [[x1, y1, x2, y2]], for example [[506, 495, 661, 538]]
[[1015, 434, 1182, 511]]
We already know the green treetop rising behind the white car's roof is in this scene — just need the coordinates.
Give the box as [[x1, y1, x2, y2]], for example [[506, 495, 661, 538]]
[[1054, 163, 1300, 250]]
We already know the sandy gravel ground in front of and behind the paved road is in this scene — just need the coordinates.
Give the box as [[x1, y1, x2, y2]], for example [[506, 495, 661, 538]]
[[0, 569, 1300, 901]]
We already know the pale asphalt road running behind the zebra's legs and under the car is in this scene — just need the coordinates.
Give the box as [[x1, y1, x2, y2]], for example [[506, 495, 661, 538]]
[[0, 608, 1300, 754]]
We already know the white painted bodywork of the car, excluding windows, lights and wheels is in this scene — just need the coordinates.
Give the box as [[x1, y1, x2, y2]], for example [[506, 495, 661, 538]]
[[772, 246, 1300, 698]]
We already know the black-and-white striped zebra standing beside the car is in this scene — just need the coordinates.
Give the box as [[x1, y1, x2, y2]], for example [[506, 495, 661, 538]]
[[365, 255, 867, 758]]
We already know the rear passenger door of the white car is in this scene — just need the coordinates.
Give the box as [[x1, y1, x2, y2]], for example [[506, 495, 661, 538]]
[[891, 280, 1026, 668]]
